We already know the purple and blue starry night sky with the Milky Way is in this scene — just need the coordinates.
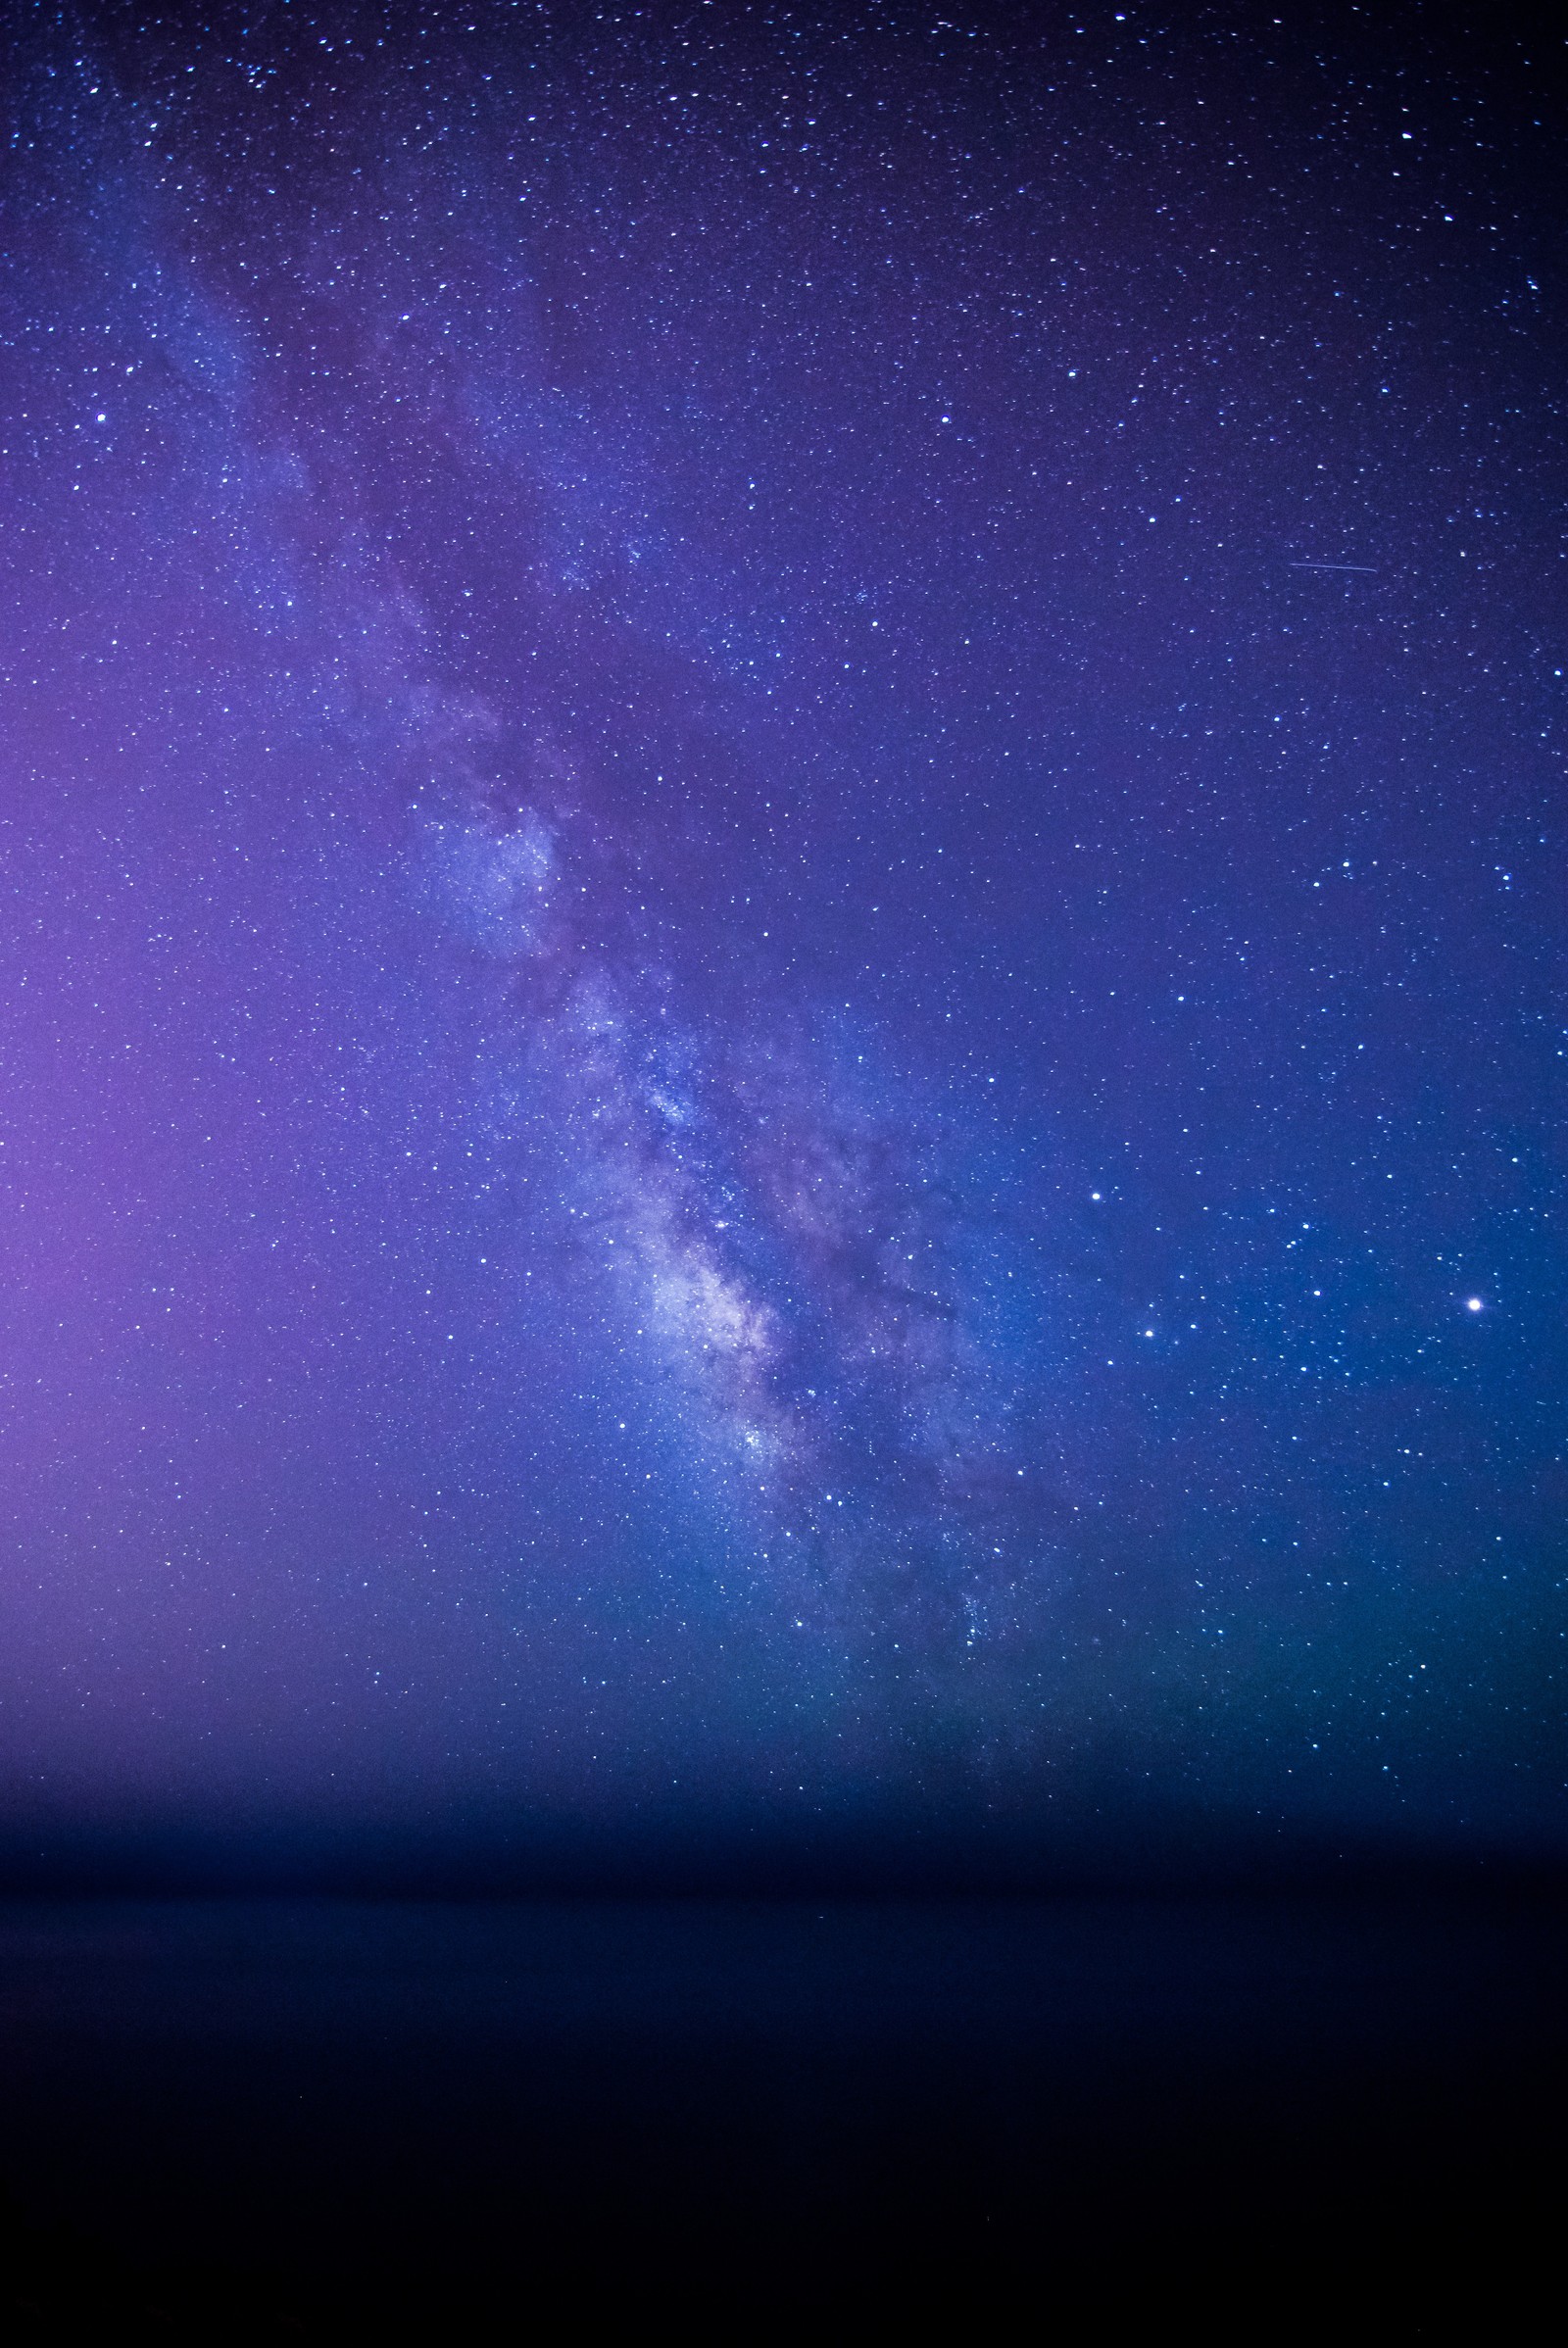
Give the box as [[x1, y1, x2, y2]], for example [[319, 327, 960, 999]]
[[0, 0, 1568, 1852]]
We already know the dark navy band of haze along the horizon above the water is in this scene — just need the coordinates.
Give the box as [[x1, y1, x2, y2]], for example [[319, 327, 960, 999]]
[[0, 1803, 1568, 1902]]
